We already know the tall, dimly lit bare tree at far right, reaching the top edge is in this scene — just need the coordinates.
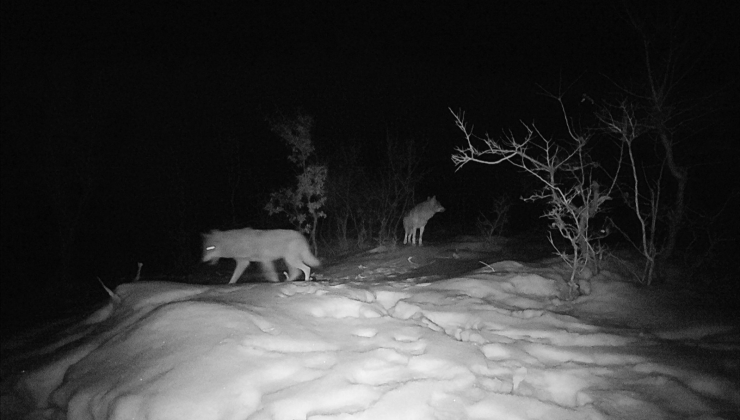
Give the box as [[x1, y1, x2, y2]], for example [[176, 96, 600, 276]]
[[607, 5, 722, 270]]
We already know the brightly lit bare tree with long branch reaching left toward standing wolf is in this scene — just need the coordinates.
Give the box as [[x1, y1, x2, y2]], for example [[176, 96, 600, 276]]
[[450, 95, 614, 297]]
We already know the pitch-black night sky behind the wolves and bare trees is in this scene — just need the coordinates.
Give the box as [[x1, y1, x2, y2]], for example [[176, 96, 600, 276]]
[[0, 0, 738, 324]]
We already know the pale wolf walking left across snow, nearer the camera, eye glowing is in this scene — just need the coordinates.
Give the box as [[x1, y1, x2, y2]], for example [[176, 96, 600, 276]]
[[203, 228, 321, 284]]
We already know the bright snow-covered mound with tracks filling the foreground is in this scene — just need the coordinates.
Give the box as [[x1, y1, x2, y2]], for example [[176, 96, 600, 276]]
[[1, 261, 740, 420]]
